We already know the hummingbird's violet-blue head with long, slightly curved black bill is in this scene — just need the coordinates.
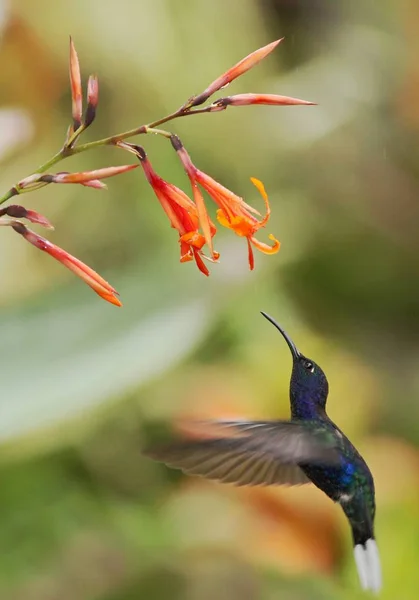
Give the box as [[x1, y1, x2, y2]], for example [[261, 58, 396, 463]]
[[262, 312, 329, 417]]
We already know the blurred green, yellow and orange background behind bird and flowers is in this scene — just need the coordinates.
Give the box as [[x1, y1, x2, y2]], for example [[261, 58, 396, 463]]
[[0, 0, 419, 600]]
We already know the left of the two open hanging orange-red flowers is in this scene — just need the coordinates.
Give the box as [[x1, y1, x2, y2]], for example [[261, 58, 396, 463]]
[[125, 142, 220, 276]]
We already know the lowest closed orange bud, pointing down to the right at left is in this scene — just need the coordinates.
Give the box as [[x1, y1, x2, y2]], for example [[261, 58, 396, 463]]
[[8, 221, 122, 306]]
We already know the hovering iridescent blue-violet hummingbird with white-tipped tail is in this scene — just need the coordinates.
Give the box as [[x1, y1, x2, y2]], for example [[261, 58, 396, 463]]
[[145, 312, 381, 592]]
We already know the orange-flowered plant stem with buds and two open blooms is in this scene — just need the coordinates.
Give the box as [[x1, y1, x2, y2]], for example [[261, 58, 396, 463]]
[[0, 38, 314, 306]]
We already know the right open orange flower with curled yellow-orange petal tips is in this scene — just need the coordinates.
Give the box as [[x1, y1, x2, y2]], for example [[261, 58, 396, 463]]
[[171, 136, 280, 270]]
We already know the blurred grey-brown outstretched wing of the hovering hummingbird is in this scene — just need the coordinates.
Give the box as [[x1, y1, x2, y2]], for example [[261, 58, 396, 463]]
[[145, 421, 339, 485]]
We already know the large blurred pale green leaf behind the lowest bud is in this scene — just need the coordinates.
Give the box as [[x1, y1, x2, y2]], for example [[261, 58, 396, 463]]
[[0, 264, 209, 454]]
